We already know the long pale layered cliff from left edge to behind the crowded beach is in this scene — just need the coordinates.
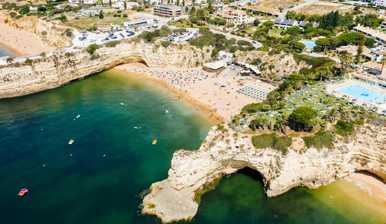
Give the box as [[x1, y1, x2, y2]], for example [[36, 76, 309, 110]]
[[0, 43, 208, 99]]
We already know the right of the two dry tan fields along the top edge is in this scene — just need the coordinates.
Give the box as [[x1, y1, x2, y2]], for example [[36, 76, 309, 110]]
[[290, 1, 354, 15]]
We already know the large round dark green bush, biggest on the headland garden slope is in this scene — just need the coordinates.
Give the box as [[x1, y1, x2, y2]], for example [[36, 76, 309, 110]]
[[288, 106, 317, 131]]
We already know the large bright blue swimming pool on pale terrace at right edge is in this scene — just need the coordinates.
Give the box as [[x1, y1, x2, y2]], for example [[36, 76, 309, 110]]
[[337, 84, 386, 103]]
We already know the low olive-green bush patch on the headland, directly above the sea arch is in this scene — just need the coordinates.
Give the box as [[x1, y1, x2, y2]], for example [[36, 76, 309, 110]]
[[252, 133, 292, 154]]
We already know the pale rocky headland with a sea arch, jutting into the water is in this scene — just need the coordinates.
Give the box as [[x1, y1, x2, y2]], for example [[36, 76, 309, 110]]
[[142, 124, 386, 223]]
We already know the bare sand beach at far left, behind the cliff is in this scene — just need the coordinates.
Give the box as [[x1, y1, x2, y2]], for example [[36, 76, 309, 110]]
[[0, 15, 53, 56]]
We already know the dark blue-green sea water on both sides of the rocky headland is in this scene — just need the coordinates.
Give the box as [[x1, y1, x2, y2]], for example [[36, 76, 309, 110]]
[[0, 72, 386, 224]]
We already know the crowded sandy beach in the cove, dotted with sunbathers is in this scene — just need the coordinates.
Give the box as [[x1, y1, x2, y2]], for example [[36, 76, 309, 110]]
[[116, 64, 274, 121]]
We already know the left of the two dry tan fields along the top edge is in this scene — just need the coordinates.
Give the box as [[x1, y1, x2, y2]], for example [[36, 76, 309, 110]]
[[244, 0, 304, 15]]
